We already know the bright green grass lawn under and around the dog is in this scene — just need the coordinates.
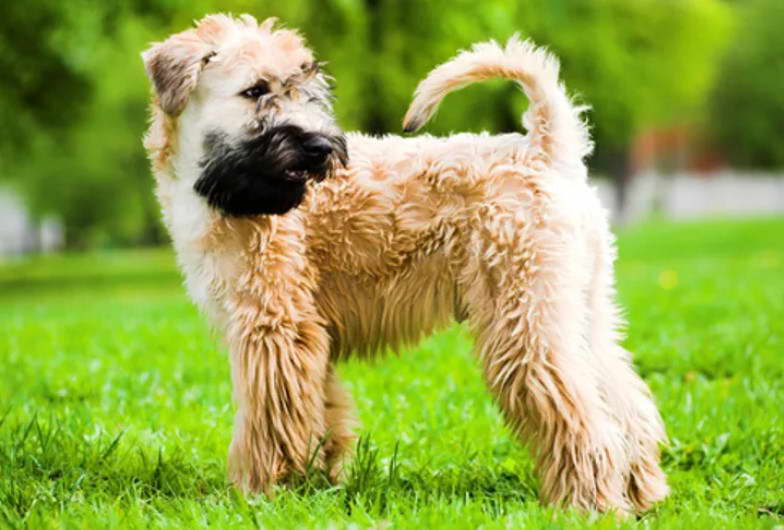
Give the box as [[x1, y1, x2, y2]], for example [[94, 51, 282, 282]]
[[0, 219, 784, 529]]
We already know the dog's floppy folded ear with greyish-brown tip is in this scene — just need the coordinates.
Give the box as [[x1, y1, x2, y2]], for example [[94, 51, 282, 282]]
[[142, 29, 215, 116]]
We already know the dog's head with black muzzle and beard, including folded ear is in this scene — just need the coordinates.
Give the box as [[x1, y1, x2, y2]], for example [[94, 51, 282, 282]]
[[143, 15, 347, 216]]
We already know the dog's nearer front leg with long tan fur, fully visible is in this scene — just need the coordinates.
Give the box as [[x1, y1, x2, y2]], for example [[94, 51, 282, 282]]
[[227, 285, 329, 492]]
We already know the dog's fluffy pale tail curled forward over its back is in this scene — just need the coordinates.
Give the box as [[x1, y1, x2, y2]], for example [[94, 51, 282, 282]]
[[403, 35, 593, 170]]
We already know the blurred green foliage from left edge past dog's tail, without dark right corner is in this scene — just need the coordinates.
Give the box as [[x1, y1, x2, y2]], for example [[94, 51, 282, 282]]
[[0, 0, 730, 247]]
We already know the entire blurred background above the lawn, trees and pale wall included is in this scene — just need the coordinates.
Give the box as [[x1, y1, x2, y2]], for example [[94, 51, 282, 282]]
[[0, 0, 784, 252]]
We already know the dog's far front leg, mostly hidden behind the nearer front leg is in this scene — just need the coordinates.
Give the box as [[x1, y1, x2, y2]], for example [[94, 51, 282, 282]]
[[324, 367, 357, 481]]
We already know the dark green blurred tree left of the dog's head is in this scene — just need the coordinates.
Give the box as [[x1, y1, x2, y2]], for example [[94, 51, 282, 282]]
[[0, 0, 172, 247]]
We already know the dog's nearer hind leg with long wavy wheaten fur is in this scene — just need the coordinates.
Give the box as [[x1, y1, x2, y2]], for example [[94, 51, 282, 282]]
[[460, 197, 632, 513]]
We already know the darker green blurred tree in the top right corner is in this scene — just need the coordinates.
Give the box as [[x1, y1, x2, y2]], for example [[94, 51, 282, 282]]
[[708, 0, 784, 169]]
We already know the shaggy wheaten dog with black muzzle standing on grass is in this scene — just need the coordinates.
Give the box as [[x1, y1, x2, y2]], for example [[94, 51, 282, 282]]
[[142, 14, 668, 514]]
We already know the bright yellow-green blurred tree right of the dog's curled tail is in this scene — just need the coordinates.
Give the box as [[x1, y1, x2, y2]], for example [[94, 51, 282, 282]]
[[543, 0, 731, 209]]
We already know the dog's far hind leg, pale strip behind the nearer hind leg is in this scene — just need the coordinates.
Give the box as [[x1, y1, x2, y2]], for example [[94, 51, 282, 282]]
[[586, 203, 668, 512]]
